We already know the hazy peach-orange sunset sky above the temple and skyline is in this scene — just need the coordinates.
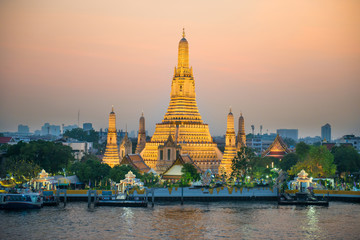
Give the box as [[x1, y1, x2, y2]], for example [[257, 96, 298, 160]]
[[0, 0, 360, 138]]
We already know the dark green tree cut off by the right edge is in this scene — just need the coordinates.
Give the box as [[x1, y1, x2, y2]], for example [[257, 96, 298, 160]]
[[331, 145, 360, 173]]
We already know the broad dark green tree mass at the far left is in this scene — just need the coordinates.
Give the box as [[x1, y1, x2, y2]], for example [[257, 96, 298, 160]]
[[5, 140, 74, 173]]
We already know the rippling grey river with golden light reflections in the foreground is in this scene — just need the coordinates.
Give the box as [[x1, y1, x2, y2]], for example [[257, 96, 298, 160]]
[[0, 202, 360, 240]]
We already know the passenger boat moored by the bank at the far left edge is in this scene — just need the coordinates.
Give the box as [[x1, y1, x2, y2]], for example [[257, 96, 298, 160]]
[[0, 193, 43, 209]]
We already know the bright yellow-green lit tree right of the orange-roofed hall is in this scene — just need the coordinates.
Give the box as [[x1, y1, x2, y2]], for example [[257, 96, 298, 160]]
[[289, 146, 336, 177]]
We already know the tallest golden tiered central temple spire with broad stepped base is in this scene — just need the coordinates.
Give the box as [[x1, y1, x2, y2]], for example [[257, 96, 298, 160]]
[[141, 32, 222, 173]]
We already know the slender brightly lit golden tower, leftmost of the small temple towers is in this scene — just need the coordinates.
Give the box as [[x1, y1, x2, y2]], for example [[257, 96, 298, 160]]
[[103, 107, 120, 167]]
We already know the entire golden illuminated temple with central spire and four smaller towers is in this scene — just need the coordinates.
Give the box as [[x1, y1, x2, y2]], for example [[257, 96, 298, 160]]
[[103, 31, 246, 174]]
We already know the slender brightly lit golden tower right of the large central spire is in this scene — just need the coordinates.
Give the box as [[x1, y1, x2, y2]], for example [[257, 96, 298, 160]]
[[220, 108, 237, 175]]
